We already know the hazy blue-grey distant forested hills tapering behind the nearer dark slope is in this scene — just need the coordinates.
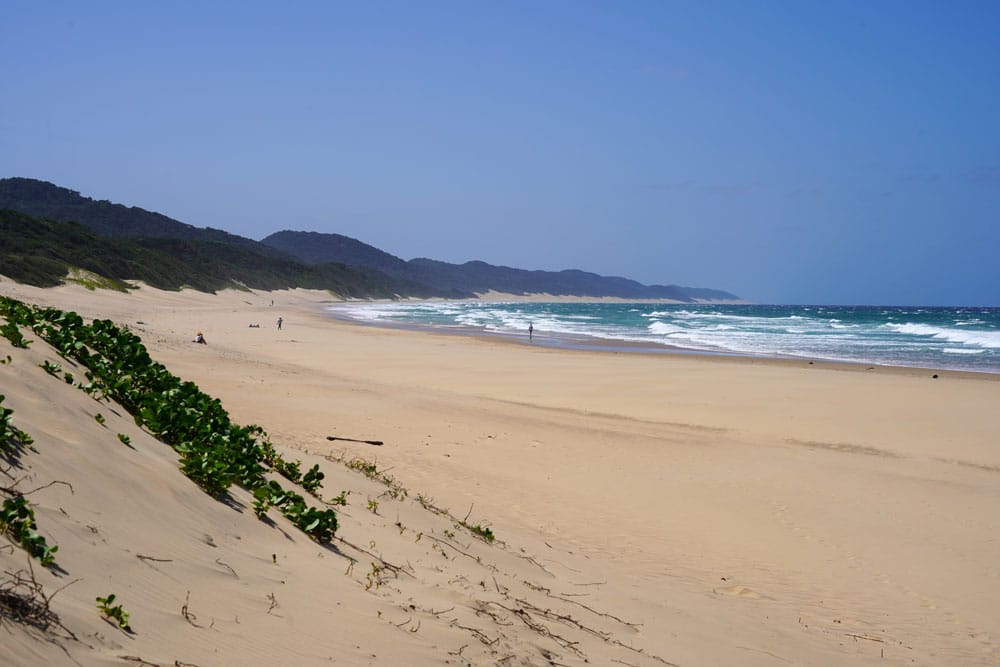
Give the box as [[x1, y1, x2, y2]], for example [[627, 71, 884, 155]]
[[261, 230, 739, 301]]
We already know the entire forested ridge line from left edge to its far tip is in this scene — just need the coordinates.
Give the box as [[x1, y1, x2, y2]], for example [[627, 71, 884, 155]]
[[0, 178, 739, 302]]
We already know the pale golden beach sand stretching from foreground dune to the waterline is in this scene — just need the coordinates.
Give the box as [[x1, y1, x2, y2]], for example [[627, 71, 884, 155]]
[[0, 280, 1000, 667]]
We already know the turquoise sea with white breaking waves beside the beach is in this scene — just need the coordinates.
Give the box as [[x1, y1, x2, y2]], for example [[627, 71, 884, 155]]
[[330, 301, 1000, 373]]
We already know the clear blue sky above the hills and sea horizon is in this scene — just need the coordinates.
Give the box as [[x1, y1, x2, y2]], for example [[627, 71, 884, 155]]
[[0, 0, 1000, 306]]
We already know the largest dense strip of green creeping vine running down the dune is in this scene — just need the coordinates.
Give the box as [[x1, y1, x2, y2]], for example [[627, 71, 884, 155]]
[[0, 297, 337, 542]]
